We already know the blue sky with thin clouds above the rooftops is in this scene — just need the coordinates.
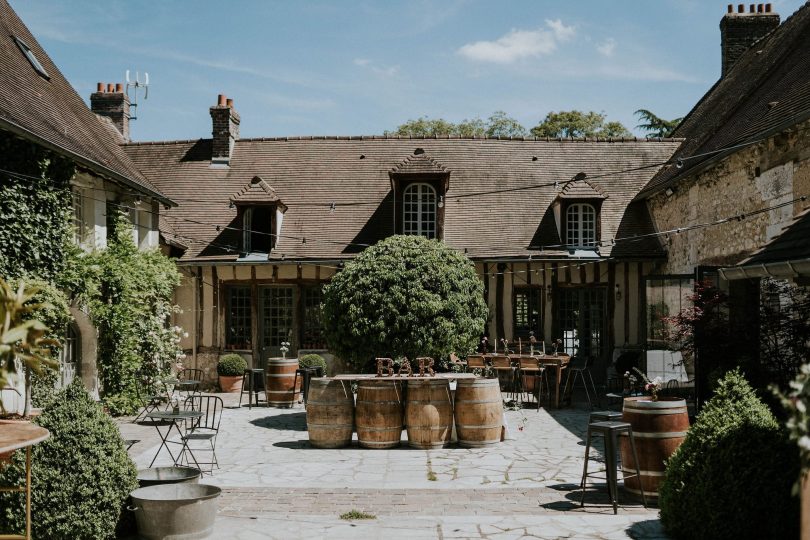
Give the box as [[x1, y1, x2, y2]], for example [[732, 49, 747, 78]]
[[10, 0, 804, 140]]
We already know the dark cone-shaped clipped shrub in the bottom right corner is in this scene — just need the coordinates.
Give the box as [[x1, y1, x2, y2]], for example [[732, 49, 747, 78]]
[[659, 370, 799, 540]]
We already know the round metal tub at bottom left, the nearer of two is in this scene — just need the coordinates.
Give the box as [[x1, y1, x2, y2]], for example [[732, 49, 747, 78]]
[[130, 484, 222, 540]]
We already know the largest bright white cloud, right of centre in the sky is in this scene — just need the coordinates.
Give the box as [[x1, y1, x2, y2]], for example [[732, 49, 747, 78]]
[[458, 19, 575, 64]]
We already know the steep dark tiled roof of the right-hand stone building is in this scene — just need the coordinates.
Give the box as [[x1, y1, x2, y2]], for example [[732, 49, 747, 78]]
[[639, 3, 810, 197]]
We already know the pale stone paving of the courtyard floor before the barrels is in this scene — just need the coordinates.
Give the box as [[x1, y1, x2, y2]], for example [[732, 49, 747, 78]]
[[120, 394, 666, 540]]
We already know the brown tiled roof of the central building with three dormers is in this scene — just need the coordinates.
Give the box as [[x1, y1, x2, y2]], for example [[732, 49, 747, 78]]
[[123, 137, 679, 261]]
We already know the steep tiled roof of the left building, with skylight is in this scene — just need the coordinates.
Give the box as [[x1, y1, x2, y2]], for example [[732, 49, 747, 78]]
[[0, 0, 171, 204]]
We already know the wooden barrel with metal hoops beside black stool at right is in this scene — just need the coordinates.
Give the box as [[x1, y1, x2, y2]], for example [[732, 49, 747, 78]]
[[619, 396, 689, 497]]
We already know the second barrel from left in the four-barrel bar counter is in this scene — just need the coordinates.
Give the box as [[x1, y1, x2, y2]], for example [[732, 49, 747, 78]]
[[354, 379, 403, 448]]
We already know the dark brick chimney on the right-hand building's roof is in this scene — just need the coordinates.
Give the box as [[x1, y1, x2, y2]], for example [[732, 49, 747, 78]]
[[720, 4, 779, 78]]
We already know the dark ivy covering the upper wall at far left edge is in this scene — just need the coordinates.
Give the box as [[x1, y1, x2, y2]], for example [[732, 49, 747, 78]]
[[0, 131, 75, 280]]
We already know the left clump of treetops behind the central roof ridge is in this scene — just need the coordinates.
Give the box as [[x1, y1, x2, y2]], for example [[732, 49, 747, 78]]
[[385, 111, 526, 137]]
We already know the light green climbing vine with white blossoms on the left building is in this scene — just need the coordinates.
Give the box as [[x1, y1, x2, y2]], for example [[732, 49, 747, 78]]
[[65, 213, 184, 414]]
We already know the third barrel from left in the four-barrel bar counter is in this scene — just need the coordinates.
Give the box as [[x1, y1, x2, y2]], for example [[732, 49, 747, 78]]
[[405, 379, 453, 450]]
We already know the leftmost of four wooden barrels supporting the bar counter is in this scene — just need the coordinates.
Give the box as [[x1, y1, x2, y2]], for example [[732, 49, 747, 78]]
[[307, 378, 354, 448]]
